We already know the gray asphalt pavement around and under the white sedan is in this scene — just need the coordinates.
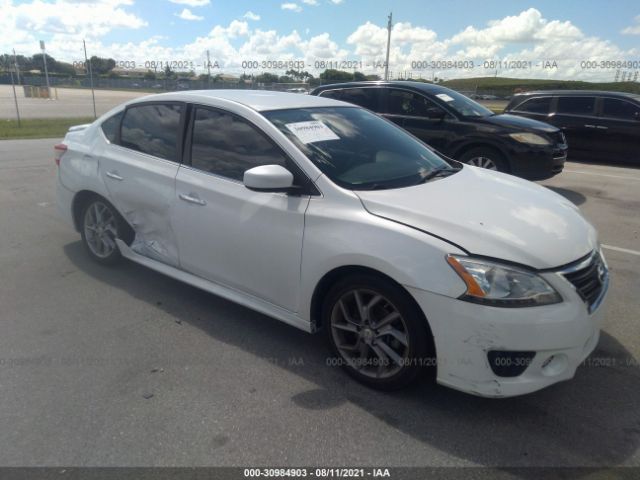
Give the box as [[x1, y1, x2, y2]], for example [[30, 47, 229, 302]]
[[0, 139, 640, 472]]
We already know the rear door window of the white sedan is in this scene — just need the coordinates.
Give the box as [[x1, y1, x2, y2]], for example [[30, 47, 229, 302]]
[[120, 104, 183, 162]]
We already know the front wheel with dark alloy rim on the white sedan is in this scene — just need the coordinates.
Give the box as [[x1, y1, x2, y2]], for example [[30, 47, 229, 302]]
[[322, 274, 435, 390]]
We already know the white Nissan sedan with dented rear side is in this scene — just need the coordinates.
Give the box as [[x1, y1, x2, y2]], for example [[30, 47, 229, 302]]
[[55, 90, 608, 397]]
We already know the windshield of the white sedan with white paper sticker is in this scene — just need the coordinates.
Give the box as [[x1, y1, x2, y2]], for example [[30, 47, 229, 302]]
[[263, 107, 450, 190]]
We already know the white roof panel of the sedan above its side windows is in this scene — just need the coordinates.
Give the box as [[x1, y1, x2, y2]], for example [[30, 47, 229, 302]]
[[128, 89, 344, 112]]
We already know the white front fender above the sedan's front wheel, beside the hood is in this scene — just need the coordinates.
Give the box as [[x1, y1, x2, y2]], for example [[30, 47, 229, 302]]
[[300, 182, 466, 321]]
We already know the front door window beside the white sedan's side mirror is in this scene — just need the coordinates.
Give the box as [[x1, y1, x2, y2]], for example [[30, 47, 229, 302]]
[[191, 108, 287, 181]]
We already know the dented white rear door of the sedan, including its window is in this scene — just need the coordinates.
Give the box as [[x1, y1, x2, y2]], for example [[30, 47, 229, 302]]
[[99, 102, 184, 266]]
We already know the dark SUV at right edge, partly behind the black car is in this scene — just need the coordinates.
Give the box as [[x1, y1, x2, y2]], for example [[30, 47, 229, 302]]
[[505, 90, 640, 163]]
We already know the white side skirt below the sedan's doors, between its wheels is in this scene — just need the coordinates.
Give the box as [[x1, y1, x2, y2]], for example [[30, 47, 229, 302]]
[[116, 238, 311, 333]]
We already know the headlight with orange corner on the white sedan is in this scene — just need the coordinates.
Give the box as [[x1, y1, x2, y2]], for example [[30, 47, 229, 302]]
[[447, 255, 562, 307]]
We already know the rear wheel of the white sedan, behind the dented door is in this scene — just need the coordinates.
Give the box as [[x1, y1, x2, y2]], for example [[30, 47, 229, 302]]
[[80, 196, 132, 265]]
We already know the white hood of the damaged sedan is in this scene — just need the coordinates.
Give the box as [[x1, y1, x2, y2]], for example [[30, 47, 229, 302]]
[[355, 166, 598, 269]]
